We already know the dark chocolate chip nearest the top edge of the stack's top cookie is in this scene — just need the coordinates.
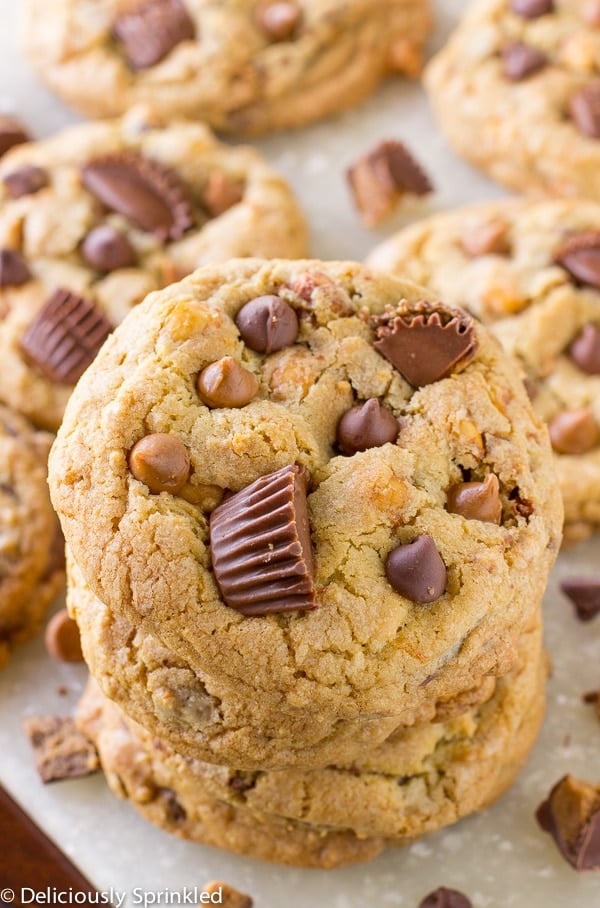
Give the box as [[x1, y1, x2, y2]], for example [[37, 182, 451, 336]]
[[235, 296, 298, 353]]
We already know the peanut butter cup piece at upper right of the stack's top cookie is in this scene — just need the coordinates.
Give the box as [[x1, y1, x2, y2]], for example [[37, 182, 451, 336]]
[[371, 302, 478, 388]]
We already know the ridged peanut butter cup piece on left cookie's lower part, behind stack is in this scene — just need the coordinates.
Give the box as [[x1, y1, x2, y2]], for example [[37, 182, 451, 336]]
[[21, 289, 113, 385]]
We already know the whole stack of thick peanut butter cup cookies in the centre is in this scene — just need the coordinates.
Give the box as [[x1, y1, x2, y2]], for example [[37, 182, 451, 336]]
[[50, 260, 562, 867]]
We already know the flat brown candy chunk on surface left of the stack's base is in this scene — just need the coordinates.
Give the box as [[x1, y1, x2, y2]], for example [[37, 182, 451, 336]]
[[23, 716, 100, 782]]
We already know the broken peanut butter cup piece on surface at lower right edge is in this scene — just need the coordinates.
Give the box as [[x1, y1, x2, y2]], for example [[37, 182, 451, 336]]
[[535, 775, 600, 870]]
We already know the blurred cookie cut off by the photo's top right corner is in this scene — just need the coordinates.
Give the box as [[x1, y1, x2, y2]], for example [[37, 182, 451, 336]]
[[425, 0, 600, 200]]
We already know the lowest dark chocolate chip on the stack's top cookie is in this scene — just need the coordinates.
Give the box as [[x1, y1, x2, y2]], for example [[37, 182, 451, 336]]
[[385, 534, 448, 604]]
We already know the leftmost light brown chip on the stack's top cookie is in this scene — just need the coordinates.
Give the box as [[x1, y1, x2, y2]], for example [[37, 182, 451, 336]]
[[129, 432, 190, 495]]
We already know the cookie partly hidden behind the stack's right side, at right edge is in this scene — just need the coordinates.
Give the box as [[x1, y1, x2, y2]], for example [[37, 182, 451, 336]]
[[368, 200, 600, 542]]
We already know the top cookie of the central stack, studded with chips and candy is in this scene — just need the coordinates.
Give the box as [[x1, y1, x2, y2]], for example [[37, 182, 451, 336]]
[[50, 260, 562, 768]]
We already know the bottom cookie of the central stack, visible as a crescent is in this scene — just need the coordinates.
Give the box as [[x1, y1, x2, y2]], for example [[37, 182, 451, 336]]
[[79, 627, 546, 867]]
